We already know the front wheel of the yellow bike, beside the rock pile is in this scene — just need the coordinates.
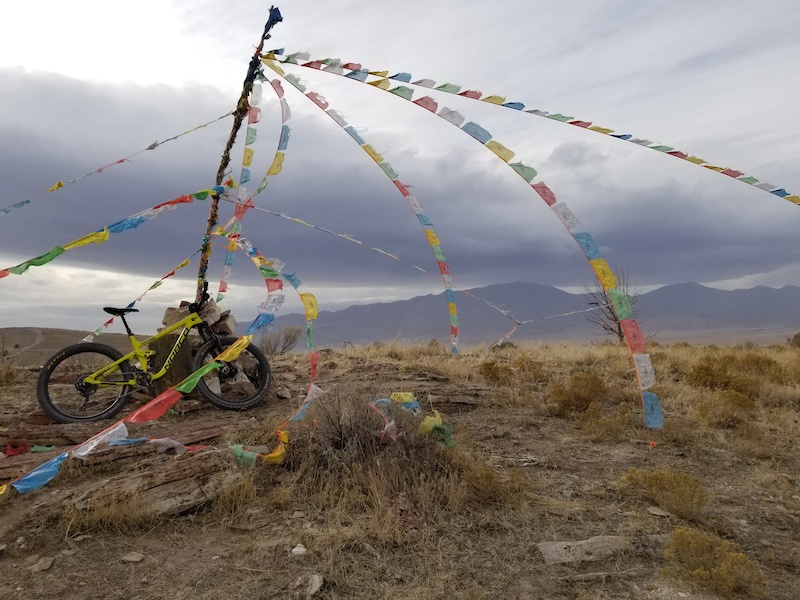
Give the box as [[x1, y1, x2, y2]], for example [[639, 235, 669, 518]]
[[193, 337, 272, 410]]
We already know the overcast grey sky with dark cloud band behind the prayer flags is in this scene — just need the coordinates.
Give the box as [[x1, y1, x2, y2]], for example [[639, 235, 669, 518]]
[[0, 0, 800, 329]]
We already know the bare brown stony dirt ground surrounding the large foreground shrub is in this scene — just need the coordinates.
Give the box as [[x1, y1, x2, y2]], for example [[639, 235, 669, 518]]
[[0, 342, 800, 600]]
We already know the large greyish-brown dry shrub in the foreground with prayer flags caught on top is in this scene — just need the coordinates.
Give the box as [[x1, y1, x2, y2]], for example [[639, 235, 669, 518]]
[[278, 386, 536, 543]]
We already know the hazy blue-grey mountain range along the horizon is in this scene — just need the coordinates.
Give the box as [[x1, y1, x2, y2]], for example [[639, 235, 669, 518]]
[[273, 282, 800, 346]]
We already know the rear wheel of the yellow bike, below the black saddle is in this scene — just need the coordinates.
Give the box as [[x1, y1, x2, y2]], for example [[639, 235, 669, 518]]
[[36, 343, 133, 423]]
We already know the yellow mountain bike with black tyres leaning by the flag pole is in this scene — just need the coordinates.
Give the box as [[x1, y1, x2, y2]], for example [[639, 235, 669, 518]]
[[36, 292, 271, 423]]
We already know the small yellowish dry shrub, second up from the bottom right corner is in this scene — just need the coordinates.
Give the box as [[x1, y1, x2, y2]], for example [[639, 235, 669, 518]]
[[617, 469, 708, 521]]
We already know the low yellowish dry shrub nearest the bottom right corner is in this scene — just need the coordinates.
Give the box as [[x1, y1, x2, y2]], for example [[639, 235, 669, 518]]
[[664, 527, 768, 598]]
